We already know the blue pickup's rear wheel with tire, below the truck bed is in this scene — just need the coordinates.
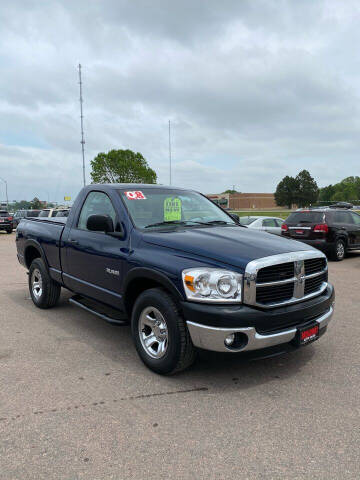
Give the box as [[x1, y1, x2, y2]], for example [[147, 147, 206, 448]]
[[29, 258, 61, 308]]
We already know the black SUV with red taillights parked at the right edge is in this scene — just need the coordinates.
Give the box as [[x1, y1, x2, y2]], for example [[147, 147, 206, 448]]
[[281, 207, 360, 261]]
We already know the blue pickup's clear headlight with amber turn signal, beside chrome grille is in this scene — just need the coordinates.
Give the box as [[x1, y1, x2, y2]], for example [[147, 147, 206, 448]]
[[182, 267, 243, 303]]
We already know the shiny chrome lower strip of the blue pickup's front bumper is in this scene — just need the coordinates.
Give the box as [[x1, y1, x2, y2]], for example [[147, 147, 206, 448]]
[[186, 306, 334, 352]]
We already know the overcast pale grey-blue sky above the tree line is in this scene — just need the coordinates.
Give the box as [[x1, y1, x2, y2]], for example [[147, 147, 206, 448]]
[[0, 0, 360, 201]]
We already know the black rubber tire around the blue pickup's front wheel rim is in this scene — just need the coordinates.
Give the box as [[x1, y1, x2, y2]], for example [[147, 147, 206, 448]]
[[131, 288, 196, 375]]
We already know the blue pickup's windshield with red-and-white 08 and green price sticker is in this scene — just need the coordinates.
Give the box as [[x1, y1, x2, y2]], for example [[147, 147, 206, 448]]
[[119, 187, 236, 230]]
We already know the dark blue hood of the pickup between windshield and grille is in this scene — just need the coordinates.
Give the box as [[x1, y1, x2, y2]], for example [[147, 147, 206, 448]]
[[143, 226, 313, 269]]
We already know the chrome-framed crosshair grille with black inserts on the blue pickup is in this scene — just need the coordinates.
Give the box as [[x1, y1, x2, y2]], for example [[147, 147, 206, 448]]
[[244, 251, 327, 308]]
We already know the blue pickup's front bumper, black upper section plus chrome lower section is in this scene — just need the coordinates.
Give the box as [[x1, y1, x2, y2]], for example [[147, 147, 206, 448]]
[[183, 284, 335, 353]]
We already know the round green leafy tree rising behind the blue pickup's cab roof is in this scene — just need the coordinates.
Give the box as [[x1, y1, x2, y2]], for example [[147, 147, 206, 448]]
[[90, 150, 157, 183]]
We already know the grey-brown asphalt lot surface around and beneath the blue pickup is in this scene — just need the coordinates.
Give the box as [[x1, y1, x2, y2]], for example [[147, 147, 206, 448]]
[[0, 232, 360, 480]]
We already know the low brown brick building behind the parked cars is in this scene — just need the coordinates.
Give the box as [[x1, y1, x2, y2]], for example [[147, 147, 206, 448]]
[[207, 193, 279, 210]]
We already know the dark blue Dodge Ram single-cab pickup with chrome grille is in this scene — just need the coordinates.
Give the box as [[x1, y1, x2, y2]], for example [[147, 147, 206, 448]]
[[16, 184, 335, 374]]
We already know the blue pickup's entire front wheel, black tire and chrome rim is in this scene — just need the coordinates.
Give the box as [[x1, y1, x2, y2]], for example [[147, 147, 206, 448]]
[[131, 288, 195, 375]]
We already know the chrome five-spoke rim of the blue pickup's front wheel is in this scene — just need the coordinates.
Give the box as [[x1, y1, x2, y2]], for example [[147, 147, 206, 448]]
[[139, 307, 169, 359]]
